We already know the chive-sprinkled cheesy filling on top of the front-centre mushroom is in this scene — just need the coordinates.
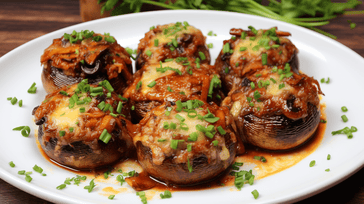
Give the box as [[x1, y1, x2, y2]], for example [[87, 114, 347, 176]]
[[133, 100, 236, 168]]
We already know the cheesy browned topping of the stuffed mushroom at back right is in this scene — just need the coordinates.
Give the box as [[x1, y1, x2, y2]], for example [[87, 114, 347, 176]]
[[215, 28, 298, 93]]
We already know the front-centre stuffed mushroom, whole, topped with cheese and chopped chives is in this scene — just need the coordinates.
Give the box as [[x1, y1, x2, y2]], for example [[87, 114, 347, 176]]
[[133, 99, 244, 185]]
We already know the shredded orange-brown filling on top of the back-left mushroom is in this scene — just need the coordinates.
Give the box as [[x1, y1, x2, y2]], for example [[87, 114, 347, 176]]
[[41, 30, 132, 80]]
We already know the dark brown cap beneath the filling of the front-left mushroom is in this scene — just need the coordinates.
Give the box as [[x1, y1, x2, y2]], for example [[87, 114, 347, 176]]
[[38, 122, 135, 170]]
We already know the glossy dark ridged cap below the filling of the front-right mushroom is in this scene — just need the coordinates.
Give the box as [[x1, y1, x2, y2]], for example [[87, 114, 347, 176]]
[[235, 103, 320, 151]]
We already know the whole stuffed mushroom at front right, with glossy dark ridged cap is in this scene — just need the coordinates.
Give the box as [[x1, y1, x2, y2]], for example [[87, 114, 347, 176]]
[[222, 63, 322, 150]]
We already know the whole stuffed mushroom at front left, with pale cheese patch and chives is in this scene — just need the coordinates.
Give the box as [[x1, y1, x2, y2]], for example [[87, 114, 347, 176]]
[[34, 80, 134, 169]]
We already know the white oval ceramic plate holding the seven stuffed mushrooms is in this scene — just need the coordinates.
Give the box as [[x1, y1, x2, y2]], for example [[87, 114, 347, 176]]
[[0, 11, 364, 204]]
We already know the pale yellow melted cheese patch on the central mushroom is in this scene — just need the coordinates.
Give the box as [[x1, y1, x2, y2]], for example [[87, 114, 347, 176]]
[[140, 61, 188, 94]]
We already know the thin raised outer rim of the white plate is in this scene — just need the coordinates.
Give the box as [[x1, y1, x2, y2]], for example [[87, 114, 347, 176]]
[[0, 10, 364, 203]]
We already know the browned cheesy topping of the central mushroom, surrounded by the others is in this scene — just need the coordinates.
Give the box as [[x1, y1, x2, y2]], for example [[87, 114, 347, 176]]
[[124, 57, 224, 120]]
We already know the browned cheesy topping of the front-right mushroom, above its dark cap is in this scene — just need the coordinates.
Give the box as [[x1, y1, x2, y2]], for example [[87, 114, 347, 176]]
[[222, 66, 322, 120]]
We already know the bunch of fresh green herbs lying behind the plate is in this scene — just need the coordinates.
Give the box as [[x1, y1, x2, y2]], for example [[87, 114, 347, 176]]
[[98, 0, 364, 39]]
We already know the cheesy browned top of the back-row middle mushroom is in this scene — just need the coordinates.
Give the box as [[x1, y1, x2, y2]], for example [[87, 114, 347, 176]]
[[136, 22, 210, 69]]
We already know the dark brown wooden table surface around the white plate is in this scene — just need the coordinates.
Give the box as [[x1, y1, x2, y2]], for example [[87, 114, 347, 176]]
[[0, 0, 364, 204]]
